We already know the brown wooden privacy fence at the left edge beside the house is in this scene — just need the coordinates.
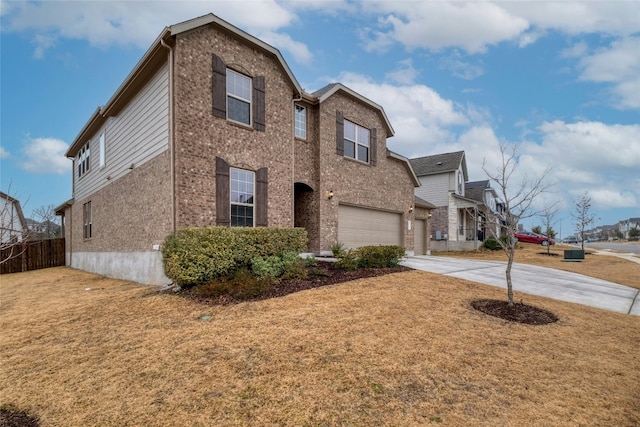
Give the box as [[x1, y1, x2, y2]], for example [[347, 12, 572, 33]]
[[0, 239, 65, 274]]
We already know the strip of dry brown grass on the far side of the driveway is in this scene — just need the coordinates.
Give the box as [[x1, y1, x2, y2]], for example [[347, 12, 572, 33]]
[[433, 243, 640, 289]]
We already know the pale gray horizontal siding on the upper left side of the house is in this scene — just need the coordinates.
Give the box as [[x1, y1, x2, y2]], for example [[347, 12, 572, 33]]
[[73, 64, 169, 200]]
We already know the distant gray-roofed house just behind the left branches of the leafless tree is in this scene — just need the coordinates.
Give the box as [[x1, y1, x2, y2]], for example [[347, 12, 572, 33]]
[[464, 180, 504, 241]]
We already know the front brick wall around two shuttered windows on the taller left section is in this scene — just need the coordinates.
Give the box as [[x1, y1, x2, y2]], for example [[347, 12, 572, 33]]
[[174, 26, 294, 228]]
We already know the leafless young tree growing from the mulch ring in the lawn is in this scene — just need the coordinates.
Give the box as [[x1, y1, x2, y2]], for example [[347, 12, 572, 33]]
[[482, 143, 550, 306]]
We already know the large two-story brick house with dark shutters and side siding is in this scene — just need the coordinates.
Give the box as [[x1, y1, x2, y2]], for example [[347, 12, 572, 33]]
[[56, 14, 428, 284]]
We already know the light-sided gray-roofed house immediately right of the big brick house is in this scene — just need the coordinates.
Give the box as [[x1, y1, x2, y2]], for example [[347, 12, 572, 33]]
[[409, 151, 480, 251]]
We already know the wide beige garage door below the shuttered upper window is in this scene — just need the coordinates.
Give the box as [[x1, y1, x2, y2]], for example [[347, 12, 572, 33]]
[[338, 206, 404, 249]]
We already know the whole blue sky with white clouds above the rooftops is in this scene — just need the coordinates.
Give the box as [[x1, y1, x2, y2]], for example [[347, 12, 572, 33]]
[[0, 0, 640, 235]]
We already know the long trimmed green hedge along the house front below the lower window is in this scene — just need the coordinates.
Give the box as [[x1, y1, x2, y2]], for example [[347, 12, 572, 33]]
[[162, 227, 307, 286]]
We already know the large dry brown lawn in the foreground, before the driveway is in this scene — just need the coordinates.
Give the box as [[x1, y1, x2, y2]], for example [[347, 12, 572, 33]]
[[0, 267, 640, 427]]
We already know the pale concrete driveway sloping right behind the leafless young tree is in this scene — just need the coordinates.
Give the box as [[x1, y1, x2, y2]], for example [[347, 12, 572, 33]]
[[401, 256, 640, 316]]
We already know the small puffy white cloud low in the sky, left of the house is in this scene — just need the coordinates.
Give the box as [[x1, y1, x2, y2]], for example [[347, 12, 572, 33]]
[[19, 138, 71, 175]]
